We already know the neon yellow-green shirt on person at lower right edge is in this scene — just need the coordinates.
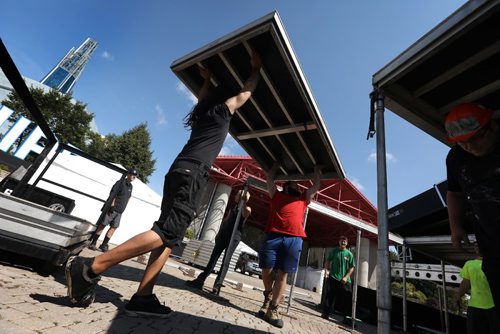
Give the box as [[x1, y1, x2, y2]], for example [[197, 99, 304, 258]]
[[460, 259, 495, 309]]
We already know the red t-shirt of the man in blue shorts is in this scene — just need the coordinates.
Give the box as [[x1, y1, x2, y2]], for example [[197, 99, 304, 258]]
[[265, 191, 309, 238]]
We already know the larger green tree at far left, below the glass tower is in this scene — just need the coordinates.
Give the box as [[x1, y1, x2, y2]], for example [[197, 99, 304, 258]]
[[2, 87, 94, 150]]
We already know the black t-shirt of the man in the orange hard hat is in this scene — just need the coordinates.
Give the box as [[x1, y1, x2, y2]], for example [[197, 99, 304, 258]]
[[446, 145, 500, 258]]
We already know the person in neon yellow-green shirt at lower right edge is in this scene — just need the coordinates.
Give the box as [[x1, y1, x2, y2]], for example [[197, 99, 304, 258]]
[[458, 249, 500, 334]]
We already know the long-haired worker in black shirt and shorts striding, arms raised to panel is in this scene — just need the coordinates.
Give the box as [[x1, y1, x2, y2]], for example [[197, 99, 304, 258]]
[[65, 53, 261, 318]]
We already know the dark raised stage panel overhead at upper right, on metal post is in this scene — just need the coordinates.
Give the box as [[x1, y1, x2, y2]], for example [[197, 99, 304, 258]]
[[372, 0, 500, 145]]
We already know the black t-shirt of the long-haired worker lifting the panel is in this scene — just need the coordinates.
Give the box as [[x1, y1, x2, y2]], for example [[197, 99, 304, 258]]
[[178, 103, 231, 166]]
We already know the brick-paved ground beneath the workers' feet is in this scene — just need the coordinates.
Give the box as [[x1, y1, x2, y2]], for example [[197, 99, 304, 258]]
[[0, 250, 388, 334]]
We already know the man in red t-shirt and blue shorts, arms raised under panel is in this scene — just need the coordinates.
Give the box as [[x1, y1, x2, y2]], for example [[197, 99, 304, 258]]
[[259, 163, 321, 328]]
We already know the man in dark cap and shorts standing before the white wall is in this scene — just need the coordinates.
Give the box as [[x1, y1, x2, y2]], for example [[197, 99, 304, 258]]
[[89, 168, 137, 252]]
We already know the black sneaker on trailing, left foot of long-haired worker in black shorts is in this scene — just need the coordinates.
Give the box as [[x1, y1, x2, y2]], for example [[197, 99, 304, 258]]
[[64, 256, 101, 307]]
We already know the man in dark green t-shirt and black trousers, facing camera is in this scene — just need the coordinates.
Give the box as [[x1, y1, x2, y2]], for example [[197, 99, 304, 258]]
[[321, 236, 355, 324]]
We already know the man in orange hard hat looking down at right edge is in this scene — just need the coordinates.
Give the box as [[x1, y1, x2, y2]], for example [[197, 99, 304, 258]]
[[445, 103, 500, 315]]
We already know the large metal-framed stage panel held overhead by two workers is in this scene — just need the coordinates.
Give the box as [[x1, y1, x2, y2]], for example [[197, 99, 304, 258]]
[[171, 12, 345, 180]]
